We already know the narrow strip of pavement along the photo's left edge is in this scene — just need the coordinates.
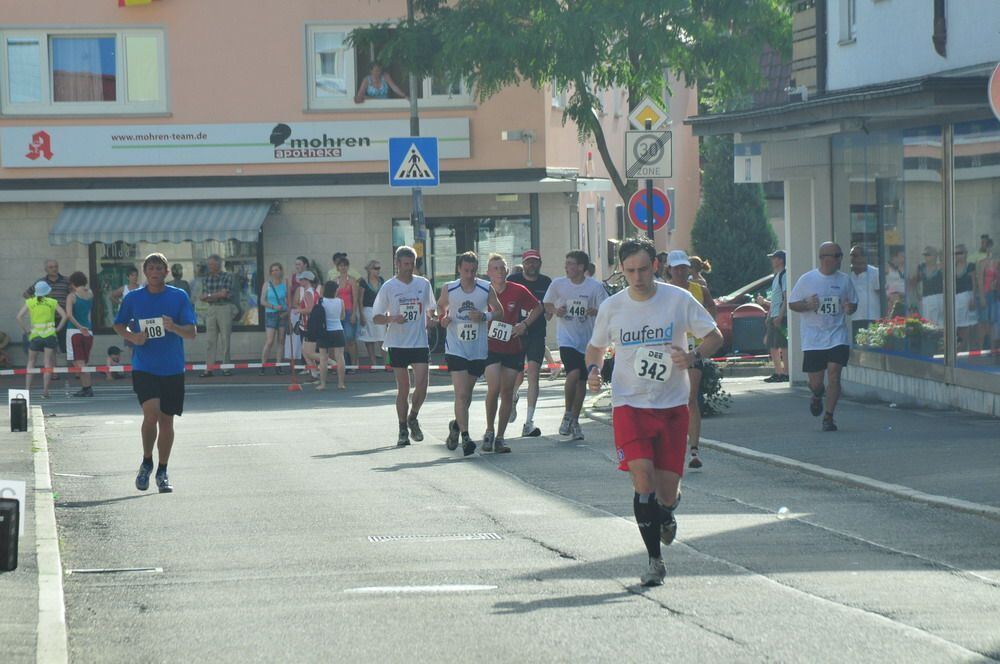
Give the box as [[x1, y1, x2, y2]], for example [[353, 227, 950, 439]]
[[0, 414, 38, 662]]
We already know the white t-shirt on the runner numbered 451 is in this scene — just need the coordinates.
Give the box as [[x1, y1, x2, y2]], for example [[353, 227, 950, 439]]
[[788, 270, 858, 350]]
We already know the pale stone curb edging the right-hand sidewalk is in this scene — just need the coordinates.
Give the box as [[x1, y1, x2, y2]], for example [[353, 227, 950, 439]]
[[583, 408, 1000, 521]]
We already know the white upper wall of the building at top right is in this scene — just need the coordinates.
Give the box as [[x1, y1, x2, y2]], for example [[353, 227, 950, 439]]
[[827, 0, 1000, 91]]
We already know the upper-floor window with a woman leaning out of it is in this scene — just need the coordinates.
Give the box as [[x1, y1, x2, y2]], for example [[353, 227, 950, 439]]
[[306, 25, 472, 109]]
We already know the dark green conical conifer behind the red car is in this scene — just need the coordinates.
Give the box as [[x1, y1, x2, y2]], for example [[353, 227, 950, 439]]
[[691, 136, 778, 296]]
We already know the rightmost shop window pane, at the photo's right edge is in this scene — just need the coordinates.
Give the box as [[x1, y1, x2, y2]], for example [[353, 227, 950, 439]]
[[953, 120, 1000, 374]]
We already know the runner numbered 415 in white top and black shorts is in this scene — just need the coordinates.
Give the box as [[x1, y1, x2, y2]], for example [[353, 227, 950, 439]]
[[438, 251, 500, 456]]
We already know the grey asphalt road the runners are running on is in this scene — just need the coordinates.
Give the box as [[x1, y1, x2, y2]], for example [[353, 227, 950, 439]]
[[35, 376, 1000, 662]]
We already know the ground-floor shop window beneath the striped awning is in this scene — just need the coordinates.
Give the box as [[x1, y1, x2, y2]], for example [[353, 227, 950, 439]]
[[90, 240, 263, 332]]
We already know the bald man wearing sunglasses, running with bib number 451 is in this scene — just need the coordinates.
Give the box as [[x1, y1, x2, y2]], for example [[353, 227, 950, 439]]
[[788, 242, 858, 431]]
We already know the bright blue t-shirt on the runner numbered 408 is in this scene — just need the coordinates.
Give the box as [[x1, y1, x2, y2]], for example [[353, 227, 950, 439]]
[[115, 285, 197, 376]]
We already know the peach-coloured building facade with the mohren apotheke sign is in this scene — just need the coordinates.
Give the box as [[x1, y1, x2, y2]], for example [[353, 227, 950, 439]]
[[0, 0, 698, 361]]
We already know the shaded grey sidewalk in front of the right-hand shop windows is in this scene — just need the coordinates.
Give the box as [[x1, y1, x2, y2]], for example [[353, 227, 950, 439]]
[[590, 379, 1000, 518]]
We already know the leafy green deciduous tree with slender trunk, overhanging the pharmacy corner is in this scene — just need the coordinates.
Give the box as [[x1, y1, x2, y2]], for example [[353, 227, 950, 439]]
[[351, 0, 791, 200]]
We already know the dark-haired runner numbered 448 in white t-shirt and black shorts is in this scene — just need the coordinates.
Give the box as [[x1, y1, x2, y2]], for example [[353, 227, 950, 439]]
[[542, 251, 608, 440]]
